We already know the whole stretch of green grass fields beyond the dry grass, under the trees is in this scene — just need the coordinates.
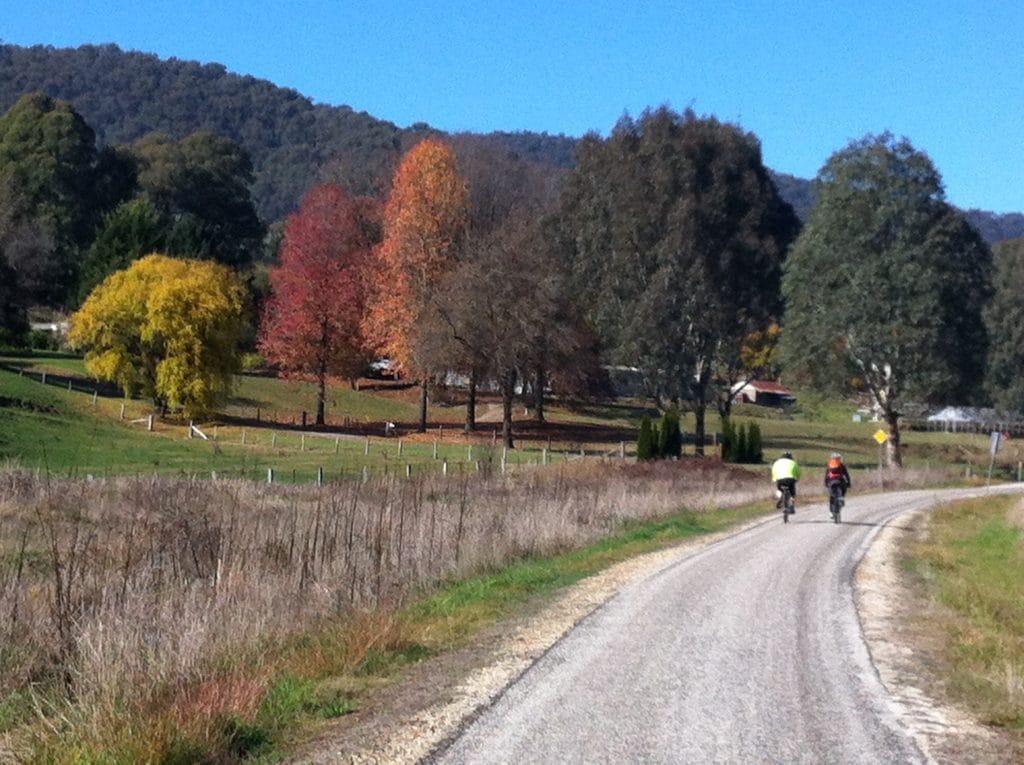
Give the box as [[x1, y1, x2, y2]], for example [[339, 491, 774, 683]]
[[8, 346, 1024, 486]]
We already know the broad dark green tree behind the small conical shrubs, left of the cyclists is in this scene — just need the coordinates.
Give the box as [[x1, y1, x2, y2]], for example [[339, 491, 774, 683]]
[[558, 108, 798, 453]]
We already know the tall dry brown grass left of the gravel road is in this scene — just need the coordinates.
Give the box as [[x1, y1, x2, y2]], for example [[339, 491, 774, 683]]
[[0, 460, 769, 761]]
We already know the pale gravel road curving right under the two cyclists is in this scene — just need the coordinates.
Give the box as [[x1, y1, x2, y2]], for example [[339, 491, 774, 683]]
[[432, 490, 1024, 763]]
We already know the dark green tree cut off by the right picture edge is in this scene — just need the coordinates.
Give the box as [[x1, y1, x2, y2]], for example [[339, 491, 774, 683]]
[[985, 239, 1024, 412]]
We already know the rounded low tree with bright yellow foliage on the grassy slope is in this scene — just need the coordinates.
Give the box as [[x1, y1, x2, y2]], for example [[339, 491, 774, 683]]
[[70, 254, 246, 415]]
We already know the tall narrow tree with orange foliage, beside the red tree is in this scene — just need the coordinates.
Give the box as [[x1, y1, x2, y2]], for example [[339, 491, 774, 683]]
[[364, 138, 469, 432]]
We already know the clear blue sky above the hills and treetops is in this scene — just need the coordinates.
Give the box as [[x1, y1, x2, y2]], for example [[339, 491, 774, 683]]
[[0, 0, 1024, 212]]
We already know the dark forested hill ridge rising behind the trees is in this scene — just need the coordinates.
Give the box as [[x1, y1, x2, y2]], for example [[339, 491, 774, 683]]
[[0, 45, 1024, 242]]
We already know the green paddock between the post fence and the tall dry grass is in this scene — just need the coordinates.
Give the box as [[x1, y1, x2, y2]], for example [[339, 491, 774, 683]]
[[0, 370, 567, 482]]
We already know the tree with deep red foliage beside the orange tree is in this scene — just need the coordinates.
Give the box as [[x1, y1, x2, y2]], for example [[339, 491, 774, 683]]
[[259, 183, 381, 425]]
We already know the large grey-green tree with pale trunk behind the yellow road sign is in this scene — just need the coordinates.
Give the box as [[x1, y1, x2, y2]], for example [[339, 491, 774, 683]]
[[782, 133, 991, 465]]
